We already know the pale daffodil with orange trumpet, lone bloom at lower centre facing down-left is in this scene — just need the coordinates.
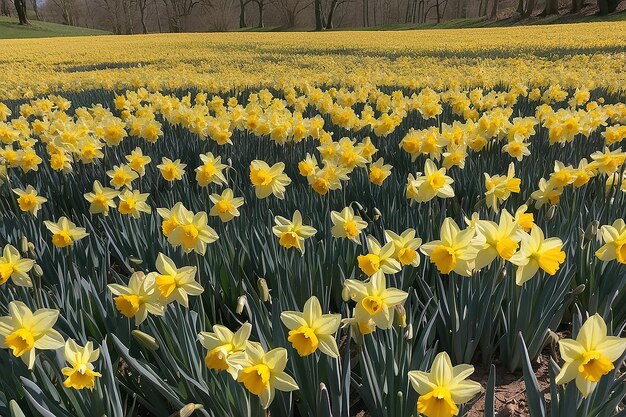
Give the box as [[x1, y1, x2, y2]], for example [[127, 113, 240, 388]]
[[280, 296, 341, 358]]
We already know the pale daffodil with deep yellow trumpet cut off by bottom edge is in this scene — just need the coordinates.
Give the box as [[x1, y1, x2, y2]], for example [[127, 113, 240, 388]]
[[409, 352, 482, 417]]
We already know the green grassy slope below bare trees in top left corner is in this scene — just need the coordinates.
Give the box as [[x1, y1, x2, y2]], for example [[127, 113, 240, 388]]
[[0, 17, 109, 39]]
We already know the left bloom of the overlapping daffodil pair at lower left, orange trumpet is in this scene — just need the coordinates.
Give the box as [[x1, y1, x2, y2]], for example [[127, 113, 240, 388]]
[[108, 272, 164, 326]]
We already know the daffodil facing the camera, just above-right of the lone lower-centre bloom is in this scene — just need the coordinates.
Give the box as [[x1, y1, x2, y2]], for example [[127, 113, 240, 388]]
[[344, 274, 408, 329]]
